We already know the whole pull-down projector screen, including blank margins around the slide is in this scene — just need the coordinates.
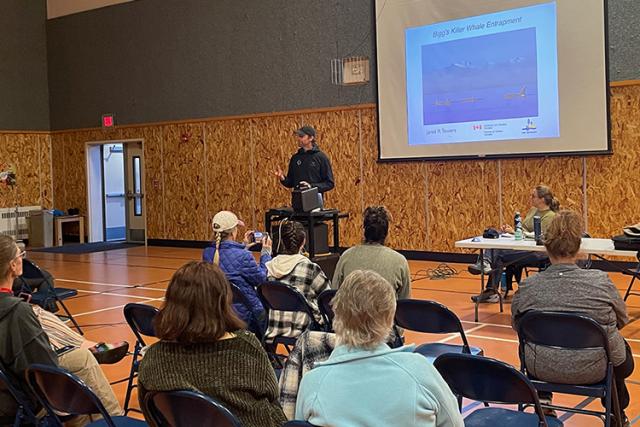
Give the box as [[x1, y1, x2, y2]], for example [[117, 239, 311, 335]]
[[375, 0, 611, 161]]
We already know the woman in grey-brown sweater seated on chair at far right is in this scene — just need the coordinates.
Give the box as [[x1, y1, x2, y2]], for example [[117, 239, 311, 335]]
[[511, 211, 634, 426]]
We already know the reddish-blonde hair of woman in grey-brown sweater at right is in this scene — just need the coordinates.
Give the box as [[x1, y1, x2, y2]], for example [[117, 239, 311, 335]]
[[544, 210, 582, 258]]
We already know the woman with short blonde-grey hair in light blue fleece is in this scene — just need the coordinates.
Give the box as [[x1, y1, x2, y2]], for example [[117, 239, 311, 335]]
[[296, 270, 464, 427]]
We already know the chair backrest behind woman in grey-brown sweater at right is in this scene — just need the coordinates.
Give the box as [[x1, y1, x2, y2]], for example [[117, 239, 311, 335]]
[[516, 311, 610, 354]]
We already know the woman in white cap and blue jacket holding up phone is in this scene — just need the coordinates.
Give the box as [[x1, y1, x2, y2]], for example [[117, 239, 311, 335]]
[[202, 211, 271, 332]]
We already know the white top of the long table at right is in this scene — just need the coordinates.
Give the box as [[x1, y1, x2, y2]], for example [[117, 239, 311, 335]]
[[455, 236, 637, 257]]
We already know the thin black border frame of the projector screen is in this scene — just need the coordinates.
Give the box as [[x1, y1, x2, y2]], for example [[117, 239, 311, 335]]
[[372, 0, 613, 163]]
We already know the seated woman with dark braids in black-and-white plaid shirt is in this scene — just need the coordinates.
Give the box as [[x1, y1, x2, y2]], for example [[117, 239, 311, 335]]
[[265, 221, 331, 339]]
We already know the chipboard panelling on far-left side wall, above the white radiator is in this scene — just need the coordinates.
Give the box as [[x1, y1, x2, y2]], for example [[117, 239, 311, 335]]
[[0, 131, 54, 208]]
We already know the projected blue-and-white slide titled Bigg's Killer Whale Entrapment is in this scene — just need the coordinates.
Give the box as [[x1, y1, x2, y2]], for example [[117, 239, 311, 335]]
[[405, 2, 560, 145]]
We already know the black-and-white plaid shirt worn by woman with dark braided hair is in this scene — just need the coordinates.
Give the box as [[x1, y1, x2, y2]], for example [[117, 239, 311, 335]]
[[265, 259, 331, 341]]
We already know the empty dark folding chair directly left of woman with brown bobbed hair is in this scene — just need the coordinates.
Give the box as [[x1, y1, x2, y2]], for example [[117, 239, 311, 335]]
[[123, 303, 160, 415]]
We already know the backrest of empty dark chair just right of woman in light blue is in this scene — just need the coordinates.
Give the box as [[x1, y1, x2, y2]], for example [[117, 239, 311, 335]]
[[433, 353, 546, 426]]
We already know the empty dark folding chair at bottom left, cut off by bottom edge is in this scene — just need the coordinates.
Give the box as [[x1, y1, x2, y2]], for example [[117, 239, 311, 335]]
[[26, 364, 147, 427]]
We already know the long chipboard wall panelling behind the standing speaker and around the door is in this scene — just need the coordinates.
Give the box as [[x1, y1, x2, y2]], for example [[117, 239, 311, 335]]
[[42, 85, 640, 252]]
